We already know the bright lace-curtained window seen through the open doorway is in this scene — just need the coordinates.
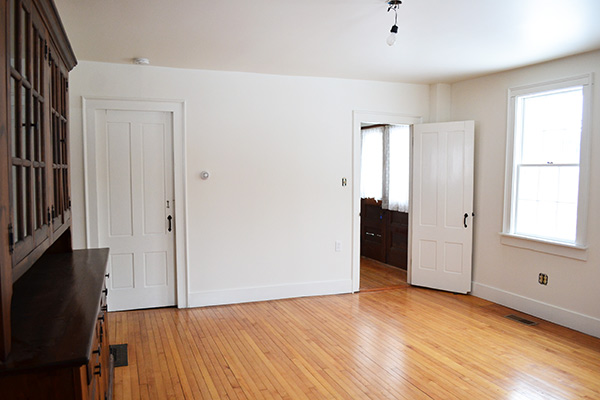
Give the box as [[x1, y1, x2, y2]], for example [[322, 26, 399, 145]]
[[360, 125, 410, 212]]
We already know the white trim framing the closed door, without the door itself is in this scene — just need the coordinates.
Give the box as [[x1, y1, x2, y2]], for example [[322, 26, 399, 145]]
[[82, 96, 189, 308]]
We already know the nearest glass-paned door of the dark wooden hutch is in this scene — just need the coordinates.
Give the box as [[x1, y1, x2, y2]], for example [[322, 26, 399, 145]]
[[8, 0, 50, 267]]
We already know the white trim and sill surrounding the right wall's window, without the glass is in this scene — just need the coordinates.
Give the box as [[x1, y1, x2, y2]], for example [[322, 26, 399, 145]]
[[500, 73, 593, 260]]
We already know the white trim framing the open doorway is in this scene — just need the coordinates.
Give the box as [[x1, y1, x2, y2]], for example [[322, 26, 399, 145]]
[[351, 110, 423, 293]]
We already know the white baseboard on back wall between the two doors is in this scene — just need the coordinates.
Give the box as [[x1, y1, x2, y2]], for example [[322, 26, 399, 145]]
[[188, 279, 352, 307]]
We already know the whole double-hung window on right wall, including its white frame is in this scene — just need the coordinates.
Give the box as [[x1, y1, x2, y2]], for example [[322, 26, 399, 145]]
[[503, 75, 591, 258]]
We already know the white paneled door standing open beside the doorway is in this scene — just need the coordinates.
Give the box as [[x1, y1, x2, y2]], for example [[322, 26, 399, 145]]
[[411, 121, 474, 293]]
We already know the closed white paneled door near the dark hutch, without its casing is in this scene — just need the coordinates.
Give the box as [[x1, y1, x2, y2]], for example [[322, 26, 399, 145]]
[[96, 110, 175, 311]]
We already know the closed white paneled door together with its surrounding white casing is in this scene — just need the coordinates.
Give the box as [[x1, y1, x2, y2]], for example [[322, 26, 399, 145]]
[[83, 98, 188, 311]]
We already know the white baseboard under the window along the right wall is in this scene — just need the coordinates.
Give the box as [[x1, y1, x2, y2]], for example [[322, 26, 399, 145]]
[[471, 282, 600, 338]]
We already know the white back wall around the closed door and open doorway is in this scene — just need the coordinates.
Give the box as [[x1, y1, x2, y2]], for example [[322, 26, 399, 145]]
[[70, 61, 429, 306]]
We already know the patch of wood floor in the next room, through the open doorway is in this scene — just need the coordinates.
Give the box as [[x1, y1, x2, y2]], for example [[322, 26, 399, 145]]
[[360, 257, 406, 292]]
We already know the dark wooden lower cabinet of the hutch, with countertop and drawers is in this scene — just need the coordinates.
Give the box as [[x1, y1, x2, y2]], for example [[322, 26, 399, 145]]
[[0, 249, 112, 400]]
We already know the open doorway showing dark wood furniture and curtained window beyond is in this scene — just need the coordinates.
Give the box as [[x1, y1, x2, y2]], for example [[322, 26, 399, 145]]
[[360, 123, 411, 291]]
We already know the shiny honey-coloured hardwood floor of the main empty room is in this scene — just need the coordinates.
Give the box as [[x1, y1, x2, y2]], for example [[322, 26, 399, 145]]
[[109, 286, 600, 400]]
